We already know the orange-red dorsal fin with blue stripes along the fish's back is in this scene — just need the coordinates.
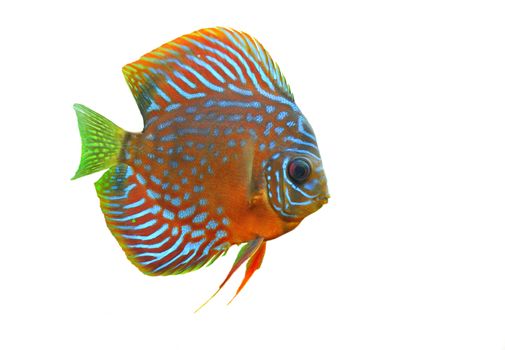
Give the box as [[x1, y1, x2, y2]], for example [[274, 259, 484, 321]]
[[123, 27, 294, 124]]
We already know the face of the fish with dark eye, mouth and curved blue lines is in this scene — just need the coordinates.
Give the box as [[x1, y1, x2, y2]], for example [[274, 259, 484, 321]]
[[264, 144, 329, 222]]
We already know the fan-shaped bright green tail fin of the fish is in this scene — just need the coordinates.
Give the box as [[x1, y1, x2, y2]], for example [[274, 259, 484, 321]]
[[72, 104, 126, 180]]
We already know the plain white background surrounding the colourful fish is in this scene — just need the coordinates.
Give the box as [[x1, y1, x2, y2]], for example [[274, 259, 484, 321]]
[[0, 0, 505, 350]]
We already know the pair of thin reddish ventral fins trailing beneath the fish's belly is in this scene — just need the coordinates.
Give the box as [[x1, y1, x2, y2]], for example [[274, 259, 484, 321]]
[[195, 237, 266, 312]]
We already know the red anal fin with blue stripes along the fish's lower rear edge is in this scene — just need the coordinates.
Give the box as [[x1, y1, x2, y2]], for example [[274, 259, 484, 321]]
[[95, 164, 226, 275]]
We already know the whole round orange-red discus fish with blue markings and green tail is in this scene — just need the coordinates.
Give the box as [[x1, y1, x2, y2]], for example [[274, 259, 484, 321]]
[[73, 28, 329, 306]]
